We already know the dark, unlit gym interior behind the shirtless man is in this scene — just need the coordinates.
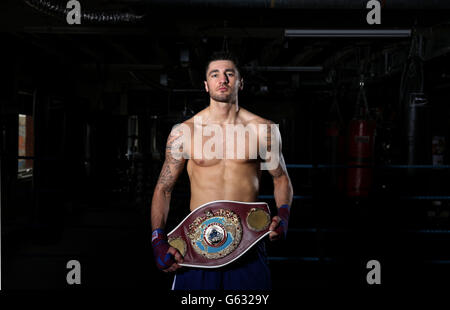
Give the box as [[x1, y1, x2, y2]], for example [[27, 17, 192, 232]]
[[0, 0, 450, 290]]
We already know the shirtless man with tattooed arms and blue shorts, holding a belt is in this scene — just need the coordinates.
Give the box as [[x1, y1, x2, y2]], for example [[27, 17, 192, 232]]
[[151, 53, 293, 289]]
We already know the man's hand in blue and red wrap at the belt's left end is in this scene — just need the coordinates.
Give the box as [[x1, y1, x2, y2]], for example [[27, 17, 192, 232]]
[[152, 228, 183, 272]]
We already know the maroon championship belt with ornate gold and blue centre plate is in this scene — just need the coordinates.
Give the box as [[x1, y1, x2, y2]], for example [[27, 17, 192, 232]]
[[167, 200, 271, 268]]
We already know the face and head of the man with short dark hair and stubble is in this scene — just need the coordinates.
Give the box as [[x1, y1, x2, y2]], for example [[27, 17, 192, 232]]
[[205, 60, 243, 103]]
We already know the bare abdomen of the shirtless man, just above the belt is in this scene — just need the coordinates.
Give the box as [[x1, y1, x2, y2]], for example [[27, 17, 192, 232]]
[[187, 160, 260, 211]]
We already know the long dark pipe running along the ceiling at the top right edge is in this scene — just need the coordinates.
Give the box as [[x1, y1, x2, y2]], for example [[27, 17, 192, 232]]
[[143, 0, 450, 10]]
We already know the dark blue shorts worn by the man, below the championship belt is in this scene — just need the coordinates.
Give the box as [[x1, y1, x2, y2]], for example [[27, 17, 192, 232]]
[[172, 241, 271, 290]]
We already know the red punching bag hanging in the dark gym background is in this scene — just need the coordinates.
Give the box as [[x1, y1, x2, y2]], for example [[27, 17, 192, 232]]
[[347, 77, 376, 198]]
